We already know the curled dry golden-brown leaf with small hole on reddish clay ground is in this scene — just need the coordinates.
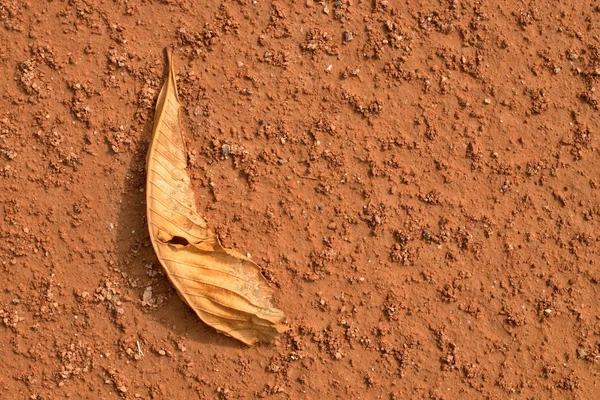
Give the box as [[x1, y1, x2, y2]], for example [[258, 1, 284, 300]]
[[146, 51, 284, 345]]
